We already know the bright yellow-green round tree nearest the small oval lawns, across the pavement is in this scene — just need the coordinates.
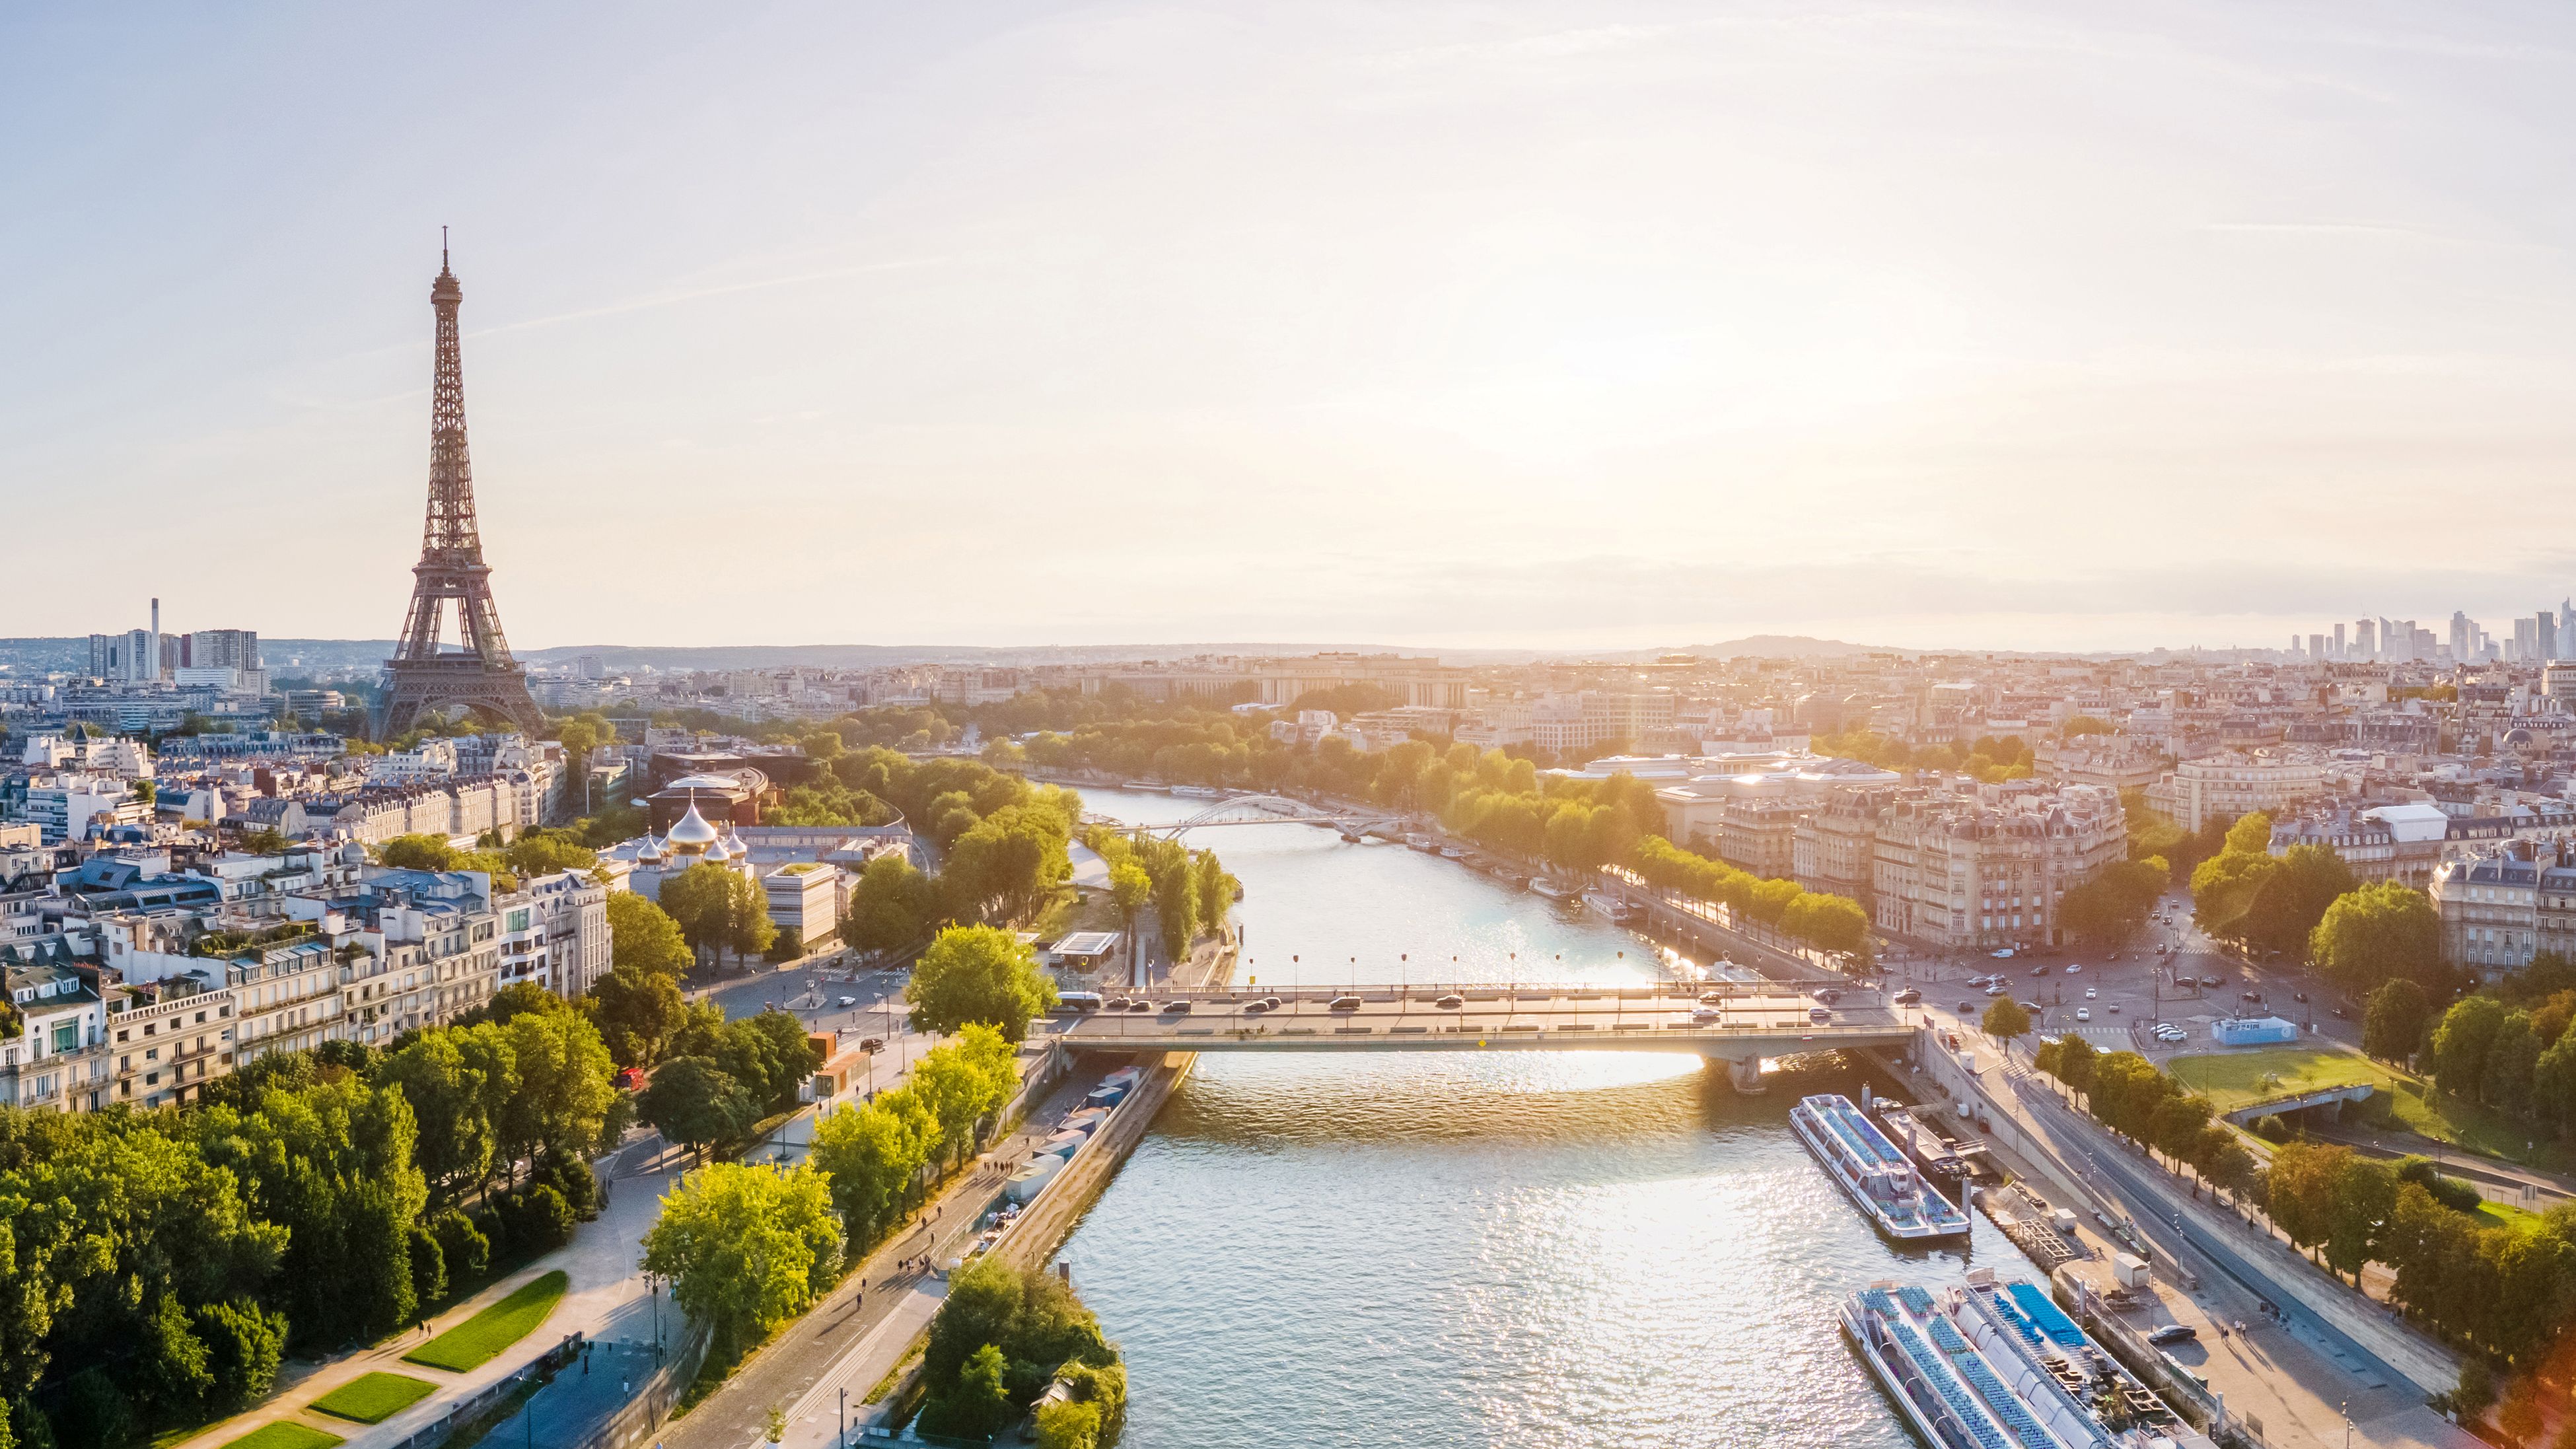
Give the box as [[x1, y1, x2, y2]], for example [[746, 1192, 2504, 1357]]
[[644, 1158, 840, 1354]]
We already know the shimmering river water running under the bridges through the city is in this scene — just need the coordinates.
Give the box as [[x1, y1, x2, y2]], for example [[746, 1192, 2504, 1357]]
[[1064, 790, 2030, 1449]]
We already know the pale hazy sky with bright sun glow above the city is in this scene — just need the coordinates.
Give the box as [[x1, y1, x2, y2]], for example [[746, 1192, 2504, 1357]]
[[0, 0, 2576, 651]]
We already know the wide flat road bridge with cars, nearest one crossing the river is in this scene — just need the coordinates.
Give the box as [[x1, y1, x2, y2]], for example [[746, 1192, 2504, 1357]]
[[1044, 981, 1917, 1088]]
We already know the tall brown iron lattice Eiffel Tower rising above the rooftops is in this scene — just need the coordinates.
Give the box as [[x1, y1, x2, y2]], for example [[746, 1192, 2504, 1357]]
[[374, 229, 546, 738]]
